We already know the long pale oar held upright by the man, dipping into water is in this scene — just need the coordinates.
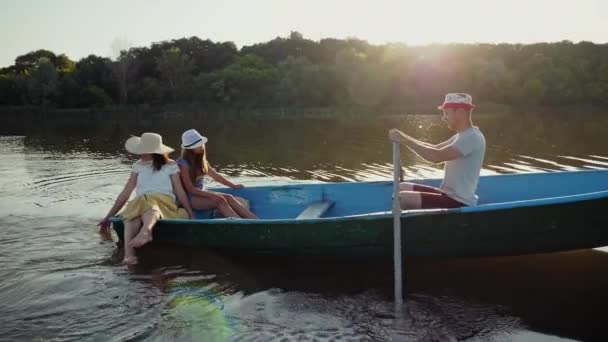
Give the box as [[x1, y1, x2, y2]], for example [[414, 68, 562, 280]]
[[393, 141, 403, 312]]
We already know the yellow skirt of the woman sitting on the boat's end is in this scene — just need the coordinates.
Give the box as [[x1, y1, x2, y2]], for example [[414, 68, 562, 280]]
[[119, 194, 188, 221]]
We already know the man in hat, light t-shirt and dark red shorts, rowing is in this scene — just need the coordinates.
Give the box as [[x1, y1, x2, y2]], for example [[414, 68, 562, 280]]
[[389, 93, 486, 209]]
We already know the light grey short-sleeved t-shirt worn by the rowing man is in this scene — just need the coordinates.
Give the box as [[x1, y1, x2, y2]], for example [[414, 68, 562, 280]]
[[440, 126, 486, 206]]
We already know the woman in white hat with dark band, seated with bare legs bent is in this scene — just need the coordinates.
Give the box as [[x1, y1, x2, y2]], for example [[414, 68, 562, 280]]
[[177, 129, 258, 219]]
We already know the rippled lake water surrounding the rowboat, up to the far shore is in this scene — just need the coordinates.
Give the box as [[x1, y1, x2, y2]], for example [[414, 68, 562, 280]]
[[0, 115, 608, 341]]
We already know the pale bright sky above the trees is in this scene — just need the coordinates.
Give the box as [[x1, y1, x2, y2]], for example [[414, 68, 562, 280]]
[[0, 0, 608, 67]]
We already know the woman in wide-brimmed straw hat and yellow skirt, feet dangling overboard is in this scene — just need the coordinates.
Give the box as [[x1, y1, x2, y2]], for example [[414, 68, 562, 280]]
[[99, 133, 192, 264]]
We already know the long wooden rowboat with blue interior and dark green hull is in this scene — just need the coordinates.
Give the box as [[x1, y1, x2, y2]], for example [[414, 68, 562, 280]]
[[113, 170, 608, 258]]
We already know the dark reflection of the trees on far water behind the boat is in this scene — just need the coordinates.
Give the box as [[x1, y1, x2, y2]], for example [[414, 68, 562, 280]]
[[16, 115, 608, 179]]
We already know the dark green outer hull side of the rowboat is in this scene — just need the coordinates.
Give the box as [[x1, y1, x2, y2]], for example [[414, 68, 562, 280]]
[[113, 197, 608, 258]]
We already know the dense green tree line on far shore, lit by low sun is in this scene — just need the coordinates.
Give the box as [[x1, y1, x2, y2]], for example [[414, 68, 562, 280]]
[[0, 32, 608, 109]]
